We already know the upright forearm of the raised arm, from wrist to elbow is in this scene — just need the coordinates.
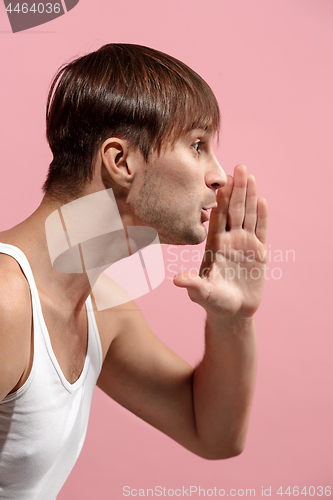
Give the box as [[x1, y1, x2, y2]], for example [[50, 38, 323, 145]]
[[193, 315, 257, 458]]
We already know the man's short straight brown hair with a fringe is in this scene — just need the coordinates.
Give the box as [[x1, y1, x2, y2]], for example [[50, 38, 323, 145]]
[[43, 44, 220, 200]]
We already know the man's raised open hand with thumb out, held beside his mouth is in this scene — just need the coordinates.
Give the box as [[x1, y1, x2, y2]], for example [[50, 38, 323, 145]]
[[174, 165, 268, 317]]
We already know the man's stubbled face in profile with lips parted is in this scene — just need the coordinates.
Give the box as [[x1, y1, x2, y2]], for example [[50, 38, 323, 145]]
[[127, 129, 227, 245]]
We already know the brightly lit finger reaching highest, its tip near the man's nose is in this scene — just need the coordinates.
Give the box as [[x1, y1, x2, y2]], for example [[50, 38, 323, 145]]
[[228, 165, 247, 229]]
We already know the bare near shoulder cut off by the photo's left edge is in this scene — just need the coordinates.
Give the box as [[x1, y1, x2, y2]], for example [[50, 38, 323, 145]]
[[0, 254, 32, 401]]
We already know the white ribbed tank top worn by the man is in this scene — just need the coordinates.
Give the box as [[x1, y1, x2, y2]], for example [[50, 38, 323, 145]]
[[0, 243, 102, 500]]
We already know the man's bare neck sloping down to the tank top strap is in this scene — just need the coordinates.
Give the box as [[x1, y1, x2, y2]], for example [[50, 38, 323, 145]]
[[0, 189, 155, 311]]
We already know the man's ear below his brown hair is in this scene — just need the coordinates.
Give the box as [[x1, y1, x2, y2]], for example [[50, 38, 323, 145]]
[[101, 137, 134, 188]]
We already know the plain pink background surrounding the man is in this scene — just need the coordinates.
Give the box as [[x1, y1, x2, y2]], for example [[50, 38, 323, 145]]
[[0, 0, 333, 500]]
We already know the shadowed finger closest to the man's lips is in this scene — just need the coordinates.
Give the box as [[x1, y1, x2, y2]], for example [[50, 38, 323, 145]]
[[207, 175, 233, 244]]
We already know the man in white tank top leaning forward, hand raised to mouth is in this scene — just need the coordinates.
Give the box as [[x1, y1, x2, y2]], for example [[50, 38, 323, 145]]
[[0, 44, 267, 499]]
